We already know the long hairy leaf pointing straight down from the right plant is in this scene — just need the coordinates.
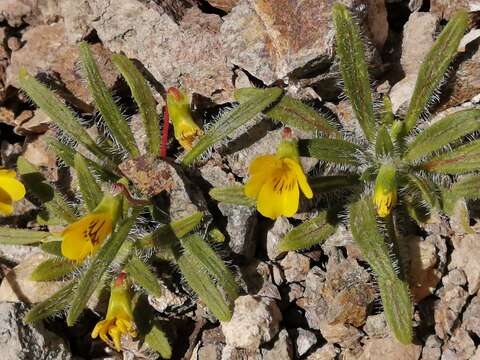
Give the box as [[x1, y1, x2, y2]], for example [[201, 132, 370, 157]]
[[350, 197, 413, 344]]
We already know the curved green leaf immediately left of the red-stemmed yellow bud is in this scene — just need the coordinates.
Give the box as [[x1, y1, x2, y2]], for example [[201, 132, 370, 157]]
[[112, 54, 161, 155]]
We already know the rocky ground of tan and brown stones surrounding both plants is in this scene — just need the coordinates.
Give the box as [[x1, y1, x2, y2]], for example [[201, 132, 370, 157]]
[[0, 0, 480, 360]]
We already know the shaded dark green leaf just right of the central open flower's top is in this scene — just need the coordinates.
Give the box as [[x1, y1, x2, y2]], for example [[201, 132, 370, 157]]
[[298, 139, 361, 165]]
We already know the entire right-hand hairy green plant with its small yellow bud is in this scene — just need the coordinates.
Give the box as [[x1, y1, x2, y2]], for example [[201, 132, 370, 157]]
[[210, 4, 472, 344]]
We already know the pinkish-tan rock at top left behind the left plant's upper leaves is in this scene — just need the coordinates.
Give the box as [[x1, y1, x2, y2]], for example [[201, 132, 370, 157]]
[[7, 22, 118, 112]]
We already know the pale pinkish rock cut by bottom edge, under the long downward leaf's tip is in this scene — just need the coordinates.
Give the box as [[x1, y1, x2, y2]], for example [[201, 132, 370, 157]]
[[360, 337, 422, 360]]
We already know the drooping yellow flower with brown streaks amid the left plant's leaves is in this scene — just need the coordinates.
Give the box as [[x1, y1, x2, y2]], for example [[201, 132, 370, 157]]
[[61, 194, 120, 262]]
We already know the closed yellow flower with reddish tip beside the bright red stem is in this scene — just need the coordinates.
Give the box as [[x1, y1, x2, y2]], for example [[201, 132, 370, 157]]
[[167, 87, 203, 150]]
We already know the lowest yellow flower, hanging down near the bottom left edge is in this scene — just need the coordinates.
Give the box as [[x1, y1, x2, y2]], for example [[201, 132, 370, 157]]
[[92, 273, 137, 351]]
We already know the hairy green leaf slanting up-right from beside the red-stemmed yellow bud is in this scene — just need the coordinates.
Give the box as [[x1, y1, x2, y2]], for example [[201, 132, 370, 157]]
[[182, 87, 282, 165]]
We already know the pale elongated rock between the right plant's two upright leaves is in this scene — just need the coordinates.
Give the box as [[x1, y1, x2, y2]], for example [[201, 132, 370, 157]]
[[390, 12, 438, 113]]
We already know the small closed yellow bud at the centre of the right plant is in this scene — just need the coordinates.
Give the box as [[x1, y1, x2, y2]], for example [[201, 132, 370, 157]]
[[373, 164, 397, 217]]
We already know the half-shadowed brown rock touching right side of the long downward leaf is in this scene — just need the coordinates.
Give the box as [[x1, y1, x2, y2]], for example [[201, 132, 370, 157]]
[[405, 236, 442, 302]]
